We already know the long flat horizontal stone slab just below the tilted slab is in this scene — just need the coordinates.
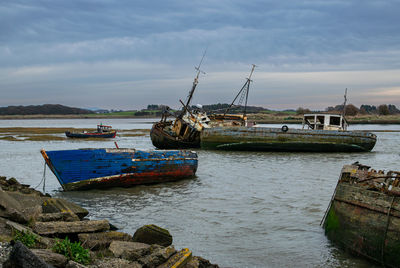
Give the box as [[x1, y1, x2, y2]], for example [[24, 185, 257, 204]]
[[33, 220, 110, 236]]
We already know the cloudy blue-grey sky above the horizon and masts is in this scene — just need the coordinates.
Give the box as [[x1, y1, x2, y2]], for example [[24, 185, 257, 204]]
[[0, 0, 400, 110]]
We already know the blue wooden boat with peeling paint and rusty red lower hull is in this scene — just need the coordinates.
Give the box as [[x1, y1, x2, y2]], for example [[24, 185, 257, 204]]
[[41, 148, 197, 191]]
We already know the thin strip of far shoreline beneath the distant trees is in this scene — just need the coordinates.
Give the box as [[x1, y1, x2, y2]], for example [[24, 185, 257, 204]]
[[0, 114, 400, 125]]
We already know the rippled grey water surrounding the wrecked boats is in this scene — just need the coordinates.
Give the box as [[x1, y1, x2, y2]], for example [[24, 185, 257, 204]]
[[0, 119, 400, 267]]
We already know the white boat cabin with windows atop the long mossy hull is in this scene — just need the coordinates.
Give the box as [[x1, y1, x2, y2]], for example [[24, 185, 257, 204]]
[[303, 114, 348, 130]]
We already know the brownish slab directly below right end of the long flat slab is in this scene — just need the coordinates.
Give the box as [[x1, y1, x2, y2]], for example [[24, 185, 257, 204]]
[[78, 231, 132, 250]]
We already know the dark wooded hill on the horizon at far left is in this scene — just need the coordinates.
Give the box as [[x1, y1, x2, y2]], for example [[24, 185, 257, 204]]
[[0, 104, 93, 115]]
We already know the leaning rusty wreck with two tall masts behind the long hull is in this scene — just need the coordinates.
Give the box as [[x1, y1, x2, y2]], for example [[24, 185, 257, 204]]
[[150, 63, 255, 149]]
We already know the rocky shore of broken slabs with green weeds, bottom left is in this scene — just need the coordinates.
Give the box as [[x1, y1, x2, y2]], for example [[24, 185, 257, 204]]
[[0, 177, 218, 268]]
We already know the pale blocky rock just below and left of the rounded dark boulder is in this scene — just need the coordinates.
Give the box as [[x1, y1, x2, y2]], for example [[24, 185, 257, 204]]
[[109, 241, 150, 261]]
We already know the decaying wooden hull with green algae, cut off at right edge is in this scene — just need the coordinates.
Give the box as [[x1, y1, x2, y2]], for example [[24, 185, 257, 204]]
[[322, 162, 400, 267]]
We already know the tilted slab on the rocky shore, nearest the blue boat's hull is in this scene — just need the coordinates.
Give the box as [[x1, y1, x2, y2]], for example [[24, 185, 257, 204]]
[[42, 198, 89, 219]]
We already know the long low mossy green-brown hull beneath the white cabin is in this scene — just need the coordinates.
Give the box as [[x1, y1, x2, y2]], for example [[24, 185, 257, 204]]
[[200, 127, 376, 152]]
